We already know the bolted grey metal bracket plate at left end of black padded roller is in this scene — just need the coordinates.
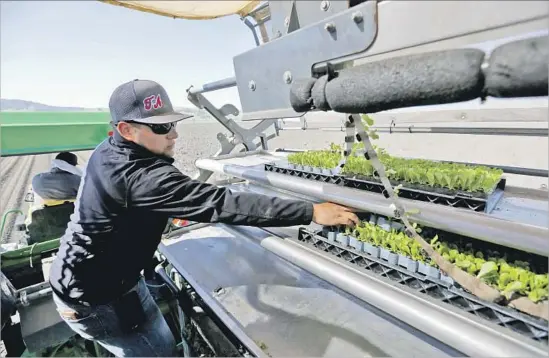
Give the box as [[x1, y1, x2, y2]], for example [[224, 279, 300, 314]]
[[233, 1, 377, 120]]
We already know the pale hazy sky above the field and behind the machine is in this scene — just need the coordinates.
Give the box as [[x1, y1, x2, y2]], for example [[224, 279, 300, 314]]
[[0, 1, 547, 112]]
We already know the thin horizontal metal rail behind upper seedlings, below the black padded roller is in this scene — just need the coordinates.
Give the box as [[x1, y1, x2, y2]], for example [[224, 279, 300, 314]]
[[371, 126, 549, 137]]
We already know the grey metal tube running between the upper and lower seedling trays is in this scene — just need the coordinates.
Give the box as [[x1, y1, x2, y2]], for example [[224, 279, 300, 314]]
[[195, 159, 549, 256]]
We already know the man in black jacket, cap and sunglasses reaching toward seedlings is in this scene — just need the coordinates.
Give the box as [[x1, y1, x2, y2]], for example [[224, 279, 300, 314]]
[[50, 80, 358, 357]]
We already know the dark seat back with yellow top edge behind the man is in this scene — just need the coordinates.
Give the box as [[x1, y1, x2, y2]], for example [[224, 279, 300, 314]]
[[26, 200, 74, 245]]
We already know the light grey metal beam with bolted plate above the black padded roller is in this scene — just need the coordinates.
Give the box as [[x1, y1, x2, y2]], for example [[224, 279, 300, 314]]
[[229, 1, 547, 120]]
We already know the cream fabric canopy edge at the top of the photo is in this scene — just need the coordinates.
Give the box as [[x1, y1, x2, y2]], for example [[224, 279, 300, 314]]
[[99, 0, 260, 20]]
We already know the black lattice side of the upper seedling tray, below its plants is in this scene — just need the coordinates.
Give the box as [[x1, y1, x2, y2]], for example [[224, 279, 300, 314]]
[[265, 163, 506, 213]]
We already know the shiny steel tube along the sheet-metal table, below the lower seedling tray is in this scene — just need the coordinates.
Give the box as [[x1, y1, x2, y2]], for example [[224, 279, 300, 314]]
[[220, 226, 546, 357]]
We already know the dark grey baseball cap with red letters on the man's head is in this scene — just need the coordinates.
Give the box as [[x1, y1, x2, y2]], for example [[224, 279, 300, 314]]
[[109, 80, 192, 125]]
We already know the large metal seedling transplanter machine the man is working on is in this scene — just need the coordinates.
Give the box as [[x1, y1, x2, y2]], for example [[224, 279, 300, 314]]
[[1, 0, 549, 357]]
